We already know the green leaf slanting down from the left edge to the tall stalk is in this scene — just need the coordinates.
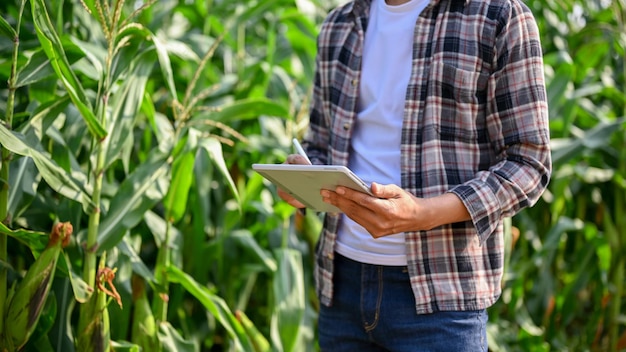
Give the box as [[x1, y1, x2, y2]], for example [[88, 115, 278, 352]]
[[0, 125, 95, 213]]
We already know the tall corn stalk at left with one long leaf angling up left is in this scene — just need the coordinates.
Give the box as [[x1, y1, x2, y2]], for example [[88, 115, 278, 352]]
[[32, 0, 132, 350]]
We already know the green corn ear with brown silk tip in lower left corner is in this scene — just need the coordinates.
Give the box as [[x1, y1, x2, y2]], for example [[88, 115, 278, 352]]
[[0, 222, 73, 351]]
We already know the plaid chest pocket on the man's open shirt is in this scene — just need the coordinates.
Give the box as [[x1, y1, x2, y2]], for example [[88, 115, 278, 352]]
[[427, 61, 489, 143]]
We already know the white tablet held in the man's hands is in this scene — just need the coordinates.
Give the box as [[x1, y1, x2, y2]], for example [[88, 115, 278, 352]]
[[252, 164, 372, 213]]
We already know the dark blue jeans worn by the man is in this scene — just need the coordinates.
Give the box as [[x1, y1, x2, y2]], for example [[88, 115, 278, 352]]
[[319, 254, 487, 352]]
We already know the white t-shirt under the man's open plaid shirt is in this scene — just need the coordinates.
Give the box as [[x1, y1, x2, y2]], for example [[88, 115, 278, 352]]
[[335, 0, 429, 265]]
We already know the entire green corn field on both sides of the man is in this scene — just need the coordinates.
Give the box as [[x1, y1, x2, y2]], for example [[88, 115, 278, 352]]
[[0, 0, 626, 352]]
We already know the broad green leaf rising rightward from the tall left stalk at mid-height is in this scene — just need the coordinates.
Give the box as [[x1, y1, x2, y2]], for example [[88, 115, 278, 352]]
[[98, 150, 170, 253]]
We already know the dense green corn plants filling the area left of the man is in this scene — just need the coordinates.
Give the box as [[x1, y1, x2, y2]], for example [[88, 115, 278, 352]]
[[0, 0, 322, 351]]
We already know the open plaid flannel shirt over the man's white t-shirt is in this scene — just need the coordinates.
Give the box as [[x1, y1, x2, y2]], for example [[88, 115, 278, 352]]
[[304, 0, 552, 314]]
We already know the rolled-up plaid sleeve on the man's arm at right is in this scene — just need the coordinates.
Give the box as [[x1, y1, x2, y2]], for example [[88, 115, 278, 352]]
[[450, 2, 552, 243]]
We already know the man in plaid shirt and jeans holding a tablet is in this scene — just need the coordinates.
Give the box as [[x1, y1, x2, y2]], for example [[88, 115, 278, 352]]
[[279, 0, 551, 351]]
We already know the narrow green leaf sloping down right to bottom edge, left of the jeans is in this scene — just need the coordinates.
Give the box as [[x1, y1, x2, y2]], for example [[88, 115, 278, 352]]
[[167, 266, 253, 351]]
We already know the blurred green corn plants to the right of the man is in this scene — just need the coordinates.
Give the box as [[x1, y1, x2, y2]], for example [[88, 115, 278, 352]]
[[491, 1, 626, 351]]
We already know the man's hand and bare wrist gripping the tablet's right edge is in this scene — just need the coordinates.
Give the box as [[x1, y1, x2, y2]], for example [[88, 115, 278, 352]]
[[321, 183, 470, 238]]
